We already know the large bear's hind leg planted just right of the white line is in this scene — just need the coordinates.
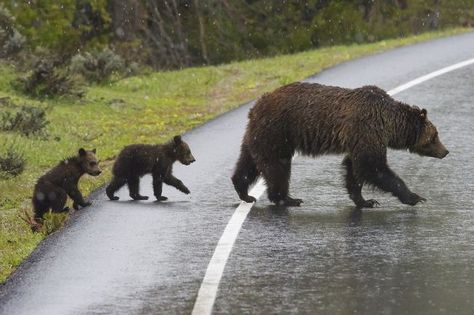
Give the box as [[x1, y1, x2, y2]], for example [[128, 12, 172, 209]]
[[262, 157, 303, 207]]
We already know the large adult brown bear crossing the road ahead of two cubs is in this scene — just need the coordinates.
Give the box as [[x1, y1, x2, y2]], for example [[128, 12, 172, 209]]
[[232, 83, 449, 208]]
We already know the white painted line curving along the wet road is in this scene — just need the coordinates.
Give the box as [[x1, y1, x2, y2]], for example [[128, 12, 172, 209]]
[[192, 58, 474, 315]]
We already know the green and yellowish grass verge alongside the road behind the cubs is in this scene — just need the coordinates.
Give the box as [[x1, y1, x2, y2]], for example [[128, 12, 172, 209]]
[[0, 29, 469, 283]]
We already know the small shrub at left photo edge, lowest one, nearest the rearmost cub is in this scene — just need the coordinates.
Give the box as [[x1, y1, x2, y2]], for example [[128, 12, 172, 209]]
[[0, 142, 26, 179]]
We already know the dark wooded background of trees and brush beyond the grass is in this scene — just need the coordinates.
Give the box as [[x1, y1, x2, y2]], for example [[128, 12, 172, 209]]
[[0, 0, 474, 69]]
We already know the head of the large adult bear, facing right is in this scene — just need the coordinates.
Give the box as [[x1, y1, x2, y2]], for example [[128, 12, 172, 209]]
[[410, 109, 449, 159]]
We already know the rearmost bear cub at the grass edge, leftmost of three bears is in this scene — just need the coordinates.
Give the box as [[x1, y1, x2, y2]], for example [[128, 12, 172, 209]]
[[32, 148, 102, 221]]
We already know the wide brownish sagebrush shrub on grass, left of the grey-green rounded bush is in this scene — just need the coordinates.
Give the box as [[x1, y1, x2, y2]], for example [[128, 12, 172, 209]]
[[14, 60, 84, 98]]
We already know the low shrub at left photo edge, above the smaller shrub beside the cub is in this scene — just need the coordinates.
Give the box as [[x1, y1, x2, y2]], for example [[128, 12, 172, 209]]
[[0, 106, 49, 136]]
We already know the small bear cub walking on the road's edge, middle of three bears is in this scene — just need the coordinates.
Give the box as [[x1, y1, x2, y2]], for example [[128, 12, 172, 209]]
[[106, 136, 196, 201]]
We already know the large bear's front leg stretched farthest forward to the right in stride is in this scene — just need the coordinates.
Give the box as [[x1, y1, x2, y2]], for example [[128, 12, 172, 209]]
[[354, 157, 426, 206]]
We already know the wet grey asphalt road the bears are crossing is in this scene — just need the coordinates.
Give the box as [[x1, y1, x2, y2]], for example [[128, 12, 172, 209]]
[[0, 33, 474, 314]]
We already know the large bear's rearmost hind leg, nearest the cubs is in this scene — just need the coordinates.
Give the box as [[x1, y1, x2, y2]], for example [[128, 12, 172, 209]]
[[232, 145, 258, 203]]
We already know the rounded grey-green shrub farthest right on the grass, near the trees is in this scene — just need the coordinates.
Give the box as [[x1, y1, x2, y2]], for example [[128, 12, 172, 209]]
[[70, 48, 126, 83]]
